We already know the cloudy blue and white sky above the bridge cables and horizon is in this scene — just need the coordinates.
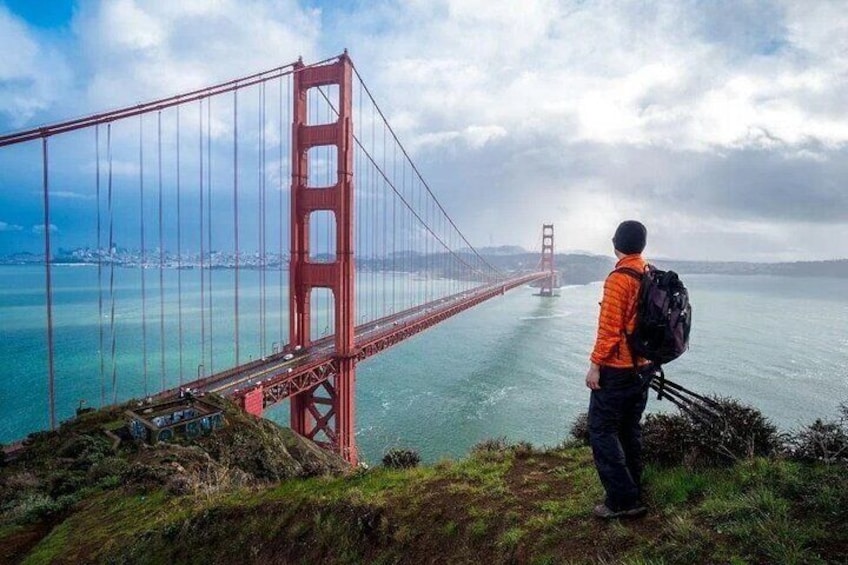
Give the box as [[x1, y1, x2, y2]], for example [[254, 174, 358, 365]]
[[0, 0, 848, 261]]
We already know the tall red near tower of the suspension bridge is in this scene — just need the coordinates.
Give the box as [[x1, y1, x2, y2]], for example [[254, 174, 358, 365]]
[[289, 55, 358, 464]]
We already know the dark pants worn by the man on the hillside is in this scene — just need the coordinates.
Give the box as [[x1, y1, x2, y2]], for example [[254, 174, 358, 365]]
[[589, 365, 653, 511]]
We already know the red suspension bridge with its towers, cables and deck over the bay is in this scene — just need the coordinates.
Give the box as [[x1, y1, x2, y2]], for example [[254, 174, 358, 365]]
[[0, 52, 556, 463]]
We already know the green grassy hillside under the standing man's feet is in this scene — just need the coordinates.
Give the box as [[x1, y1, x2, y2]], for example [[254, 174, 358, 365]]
[[0, 398, 848, 564]]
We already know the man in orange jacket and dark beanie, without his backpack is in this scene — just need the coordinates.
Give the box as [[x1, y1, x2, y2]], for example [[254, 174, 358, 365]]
[[586, 220, 652, 519]]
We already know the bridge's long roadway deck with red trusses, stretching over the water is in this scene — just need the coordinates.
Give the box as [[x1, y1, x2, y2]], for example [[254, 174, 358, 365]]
[[170, 272, 550, 408]]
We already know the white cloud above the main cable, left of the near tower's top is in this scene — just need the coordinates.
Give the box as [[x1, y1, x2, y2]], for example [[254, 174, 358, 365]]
[[68, 0, 320, 111]]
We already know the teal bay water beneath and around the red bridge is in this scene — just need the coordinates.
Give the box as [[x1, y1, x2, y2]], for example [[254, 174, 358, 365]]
[[0, 266, 848, 462]]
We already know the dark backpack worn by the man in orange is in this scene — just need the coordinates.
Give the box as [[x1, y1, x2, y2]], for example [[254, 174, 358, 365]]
[[616, 265, 692, 365]]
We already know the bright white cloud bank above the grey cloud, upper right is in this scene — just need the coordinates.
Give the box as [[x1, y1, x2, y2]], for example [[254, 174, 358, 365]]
[[354, 0, 848, 150]]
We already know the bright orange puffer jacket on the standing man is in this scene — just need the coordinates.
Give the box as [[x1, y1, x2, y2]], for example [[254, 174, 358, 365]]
[[591, 253, 647, 368]]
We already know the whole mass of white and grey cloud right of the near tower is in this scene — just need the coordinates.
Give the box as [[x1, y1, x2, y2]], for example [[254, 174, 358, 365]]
[[332, 0, 848, 259]]
